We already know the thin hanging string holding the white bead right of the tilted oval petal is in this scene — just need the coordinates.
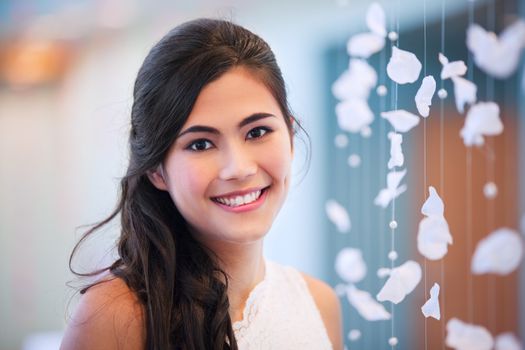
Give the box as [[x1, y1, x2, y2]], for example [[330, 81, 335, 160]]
[[439, 0, 447, 350]]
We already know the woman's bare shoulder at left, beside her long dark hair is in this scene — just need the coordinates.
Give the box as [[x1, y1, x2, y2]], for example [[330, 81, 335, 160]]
[[60, 277, 146, 350]]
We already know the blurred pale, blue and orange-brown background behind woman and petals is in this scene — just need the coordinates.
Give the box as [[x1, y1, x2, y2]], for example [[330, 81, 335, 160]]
[[0, 0, 525, 350]]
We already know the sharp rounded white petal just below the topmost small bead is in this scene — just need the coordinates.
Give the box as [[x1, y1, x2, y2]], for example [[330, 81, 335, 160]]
[[386, 46, 422, 84]]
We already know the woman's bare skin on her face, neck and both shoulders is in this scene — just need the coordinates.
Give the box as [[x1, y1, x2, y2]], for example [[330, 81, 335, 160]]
[[61, 67, 343, 350]]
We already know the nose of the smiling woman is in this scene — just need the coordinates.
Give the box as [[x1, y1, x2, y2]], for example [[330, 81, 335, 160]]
[[219, 145, 257, 180]]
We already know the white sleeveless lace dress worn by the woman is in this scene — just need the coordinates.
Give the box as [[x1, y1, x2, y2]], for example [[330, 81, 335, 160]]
[[233, 261, 332, 350]]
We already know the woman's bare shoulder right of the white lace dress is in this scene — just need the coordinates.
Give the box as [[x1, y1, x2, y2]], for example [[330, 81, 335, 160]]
[[301, 273, 343, 350]]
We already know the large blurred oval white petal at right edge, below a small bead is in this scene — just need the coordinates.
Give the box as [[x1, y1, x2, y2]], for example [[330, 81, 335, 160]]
[[471, 227, 523, 275]]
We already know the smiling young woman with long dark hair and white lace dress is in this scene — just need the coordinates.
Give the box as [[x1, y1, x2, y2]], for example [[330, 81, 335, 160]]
[[62, 19, 342, 350]]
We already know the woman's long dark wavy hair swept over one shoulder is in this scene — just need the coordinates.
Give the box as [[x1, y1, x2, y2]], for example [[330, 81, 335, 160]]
[[69, 19, 300, 350]]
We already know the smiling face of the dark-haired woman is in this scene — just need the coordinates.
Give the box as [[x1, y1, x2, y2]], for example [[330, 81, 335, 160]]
[[150, 67, 293, 243]]
